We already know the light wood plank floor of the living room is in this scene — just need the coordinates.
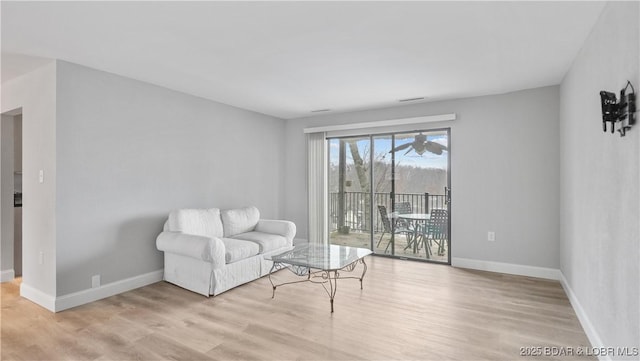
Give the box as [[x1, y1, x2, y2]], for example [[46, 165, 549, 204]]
[[0, 257, 589, 360]]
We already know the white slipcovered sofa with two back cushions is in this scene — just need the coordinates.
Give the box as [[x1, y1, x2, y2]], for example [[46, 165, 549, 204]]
[[156, 207, 296, 296]]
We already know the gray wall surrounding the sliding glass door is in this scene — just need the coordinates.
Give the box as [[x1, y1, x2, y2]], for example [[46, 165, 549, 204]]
[[285, 87, 559, 269]]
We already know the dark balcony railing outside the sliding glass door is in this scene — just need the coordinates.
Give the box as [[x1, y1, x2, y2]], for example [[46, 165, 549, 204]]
[[329, 192, 447, 232]]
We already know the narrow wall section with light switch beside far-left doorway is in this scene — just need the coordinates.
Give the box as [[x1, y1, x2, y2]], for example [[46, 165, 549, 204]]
[[2, 62, 56, 297]]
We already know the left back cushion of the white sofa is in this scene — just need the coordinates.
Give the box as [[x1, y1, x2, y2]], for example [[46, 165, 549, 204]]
[[168, 208, 224, 237]]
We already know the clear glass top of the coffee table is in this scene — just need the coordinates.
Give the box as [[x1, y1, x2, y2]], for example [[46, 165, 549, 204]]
[[267, 244, 372, 271]]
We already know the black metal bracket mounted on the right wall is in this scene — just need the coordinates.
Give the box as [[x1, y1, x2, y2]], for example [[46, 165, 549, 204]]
[[600, 81, 636, 137]]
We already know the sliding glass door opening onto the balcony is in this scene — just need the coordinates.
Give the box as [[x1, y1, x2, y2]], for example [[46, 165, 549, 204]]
[[328, 129, 450, 263]]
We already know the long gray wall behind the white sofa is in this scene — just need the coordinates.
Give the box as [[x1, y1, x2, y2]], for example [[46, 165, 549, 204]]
[[56, 62, 285, 296]]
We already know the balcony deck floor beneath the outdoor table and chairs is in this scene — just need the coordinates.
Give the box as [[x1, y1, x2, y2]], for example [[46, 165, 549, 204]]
[[329, 232, 448, 263]]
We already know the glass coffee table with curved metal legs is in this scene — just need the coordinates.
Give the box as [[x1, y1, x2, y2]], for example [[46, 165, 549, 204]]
[[266, 245, 372, 312]]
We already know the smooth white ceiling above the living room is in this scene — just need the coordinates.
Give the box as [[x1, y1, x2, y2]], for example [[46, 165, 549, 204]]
[[1, 1, 604, 119]]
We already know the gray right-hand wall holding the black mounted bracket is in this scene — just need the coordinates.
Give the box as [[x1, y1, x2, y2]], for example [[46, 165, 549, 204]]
[[560, 2, 640, 347]]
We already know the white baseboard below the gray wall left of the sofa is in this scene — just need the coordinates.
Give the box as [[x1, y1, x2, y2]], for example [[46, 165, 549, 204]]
[[55, 270, 164, 312]]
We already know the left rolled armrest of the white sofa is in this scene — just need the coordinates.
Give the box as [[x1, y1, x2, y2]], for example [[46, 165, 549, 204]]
[[156, 231, 225, 268]]
